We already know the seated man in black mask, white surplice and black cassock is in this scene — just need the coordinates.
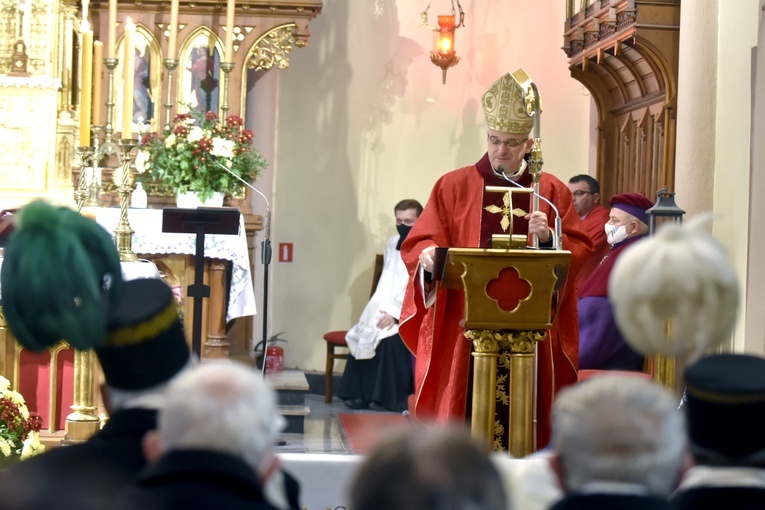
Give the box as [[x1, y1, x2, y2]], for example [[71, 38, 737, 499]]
[[339, 199, 422, 412]]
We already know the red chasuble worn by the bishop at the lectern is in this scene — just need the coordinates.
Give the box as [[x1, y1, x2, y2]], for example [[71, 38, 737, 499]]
[[399, 155, 592, 448]]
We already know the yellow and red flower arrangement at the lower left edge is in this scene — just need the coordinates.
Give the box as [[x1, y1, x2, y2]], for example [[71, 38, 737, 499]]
[[0, 376, 45, 460]]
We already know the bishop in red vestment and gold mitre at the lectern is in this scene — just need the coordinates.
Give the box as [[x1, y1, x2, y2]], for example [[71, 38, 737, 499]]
[[399, 70, 592, 448]]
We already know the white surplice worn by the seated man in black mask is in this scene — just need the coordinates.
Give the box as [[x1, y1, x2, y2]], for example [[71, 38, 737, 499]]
[[345, 236, 409, 359]]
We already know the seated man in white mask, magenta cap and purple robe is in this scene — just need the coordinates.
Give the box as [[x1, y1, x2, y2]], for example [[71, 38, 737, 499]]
[[577, 193, 653, 370]]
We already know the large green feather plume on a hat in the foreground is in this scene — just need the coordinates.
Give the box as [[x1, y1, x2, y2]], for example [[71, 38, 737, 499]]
[[0, 200, 123, 351]]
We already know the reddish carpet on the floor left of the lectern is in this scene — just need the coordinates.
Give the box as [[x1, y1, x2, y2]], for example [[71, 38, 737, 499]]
[[337, 413, 413, 454]]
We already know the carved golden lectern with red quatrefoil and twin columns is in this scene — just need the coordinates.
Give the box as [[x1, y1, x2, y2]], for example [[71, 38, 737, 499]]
[[437, 248, 571, 457]]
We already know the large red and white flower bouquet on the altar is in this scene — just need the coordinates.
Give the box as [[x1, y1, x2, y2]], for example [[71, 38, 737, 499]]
[[135, 110, 267, 200]]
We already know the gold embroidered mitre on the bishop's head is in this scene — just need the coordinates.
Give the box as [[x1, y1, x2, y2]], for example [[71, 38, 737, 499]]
[[482, 69, 542, 135]]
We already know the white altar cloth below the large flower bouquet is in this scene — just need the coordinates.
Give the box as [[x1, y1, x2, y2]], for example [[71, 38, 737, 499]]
[[96, 207, 257, 321]]
